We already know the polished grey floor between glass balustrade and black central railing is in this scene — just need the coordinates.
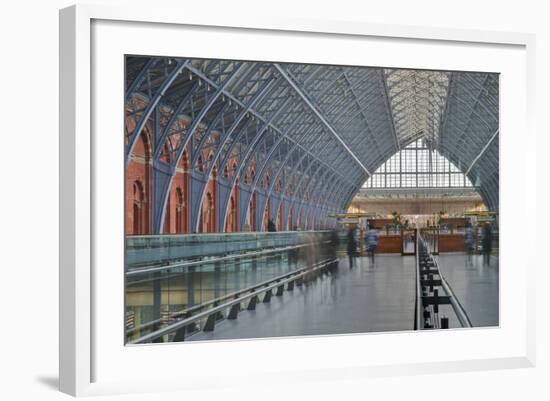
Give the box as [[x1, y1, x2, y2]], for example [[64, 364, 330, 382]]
[[190, 255, 416, 341]]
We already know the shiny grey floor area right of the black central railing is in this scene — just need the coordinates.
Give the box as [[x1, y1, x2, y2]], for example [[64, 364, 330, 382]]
[[437, 253, 499, 327]]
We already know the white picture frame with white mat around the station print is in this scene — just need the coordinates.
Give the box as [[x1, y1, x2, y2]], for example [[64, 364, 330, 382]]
[[60, 5, 537, 396]]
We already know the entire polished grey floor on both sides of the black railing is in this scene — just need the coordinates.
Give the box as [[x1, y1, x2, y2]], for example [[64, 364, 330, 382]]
[[186, 253, 499, 341]]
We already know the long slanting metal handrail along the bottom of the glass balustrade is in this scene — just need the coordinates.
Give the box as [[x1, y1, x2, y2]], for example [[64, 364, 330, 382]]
[[127, 259, 337, 345]]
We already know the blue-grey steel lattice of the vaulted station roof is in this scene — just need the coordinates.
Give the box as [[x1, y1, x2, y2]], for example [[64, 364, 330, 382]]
[[125, 56, 498, 229]]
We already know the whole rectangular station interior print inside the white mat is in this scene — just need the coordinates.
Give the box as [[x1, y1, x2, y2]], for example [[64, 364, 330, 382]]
[[124, 56, 499, 344]]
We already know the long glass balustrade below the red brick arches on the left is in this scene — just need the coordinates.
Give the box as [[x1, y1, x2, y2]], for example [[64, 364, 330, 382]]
[[126, 231, 338, 341]]
